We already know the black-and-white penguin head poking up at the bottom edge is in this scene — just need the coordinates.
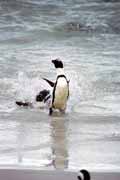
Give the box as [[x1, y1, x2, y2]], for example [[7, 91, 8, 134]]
[[77, 169, 91, 180]]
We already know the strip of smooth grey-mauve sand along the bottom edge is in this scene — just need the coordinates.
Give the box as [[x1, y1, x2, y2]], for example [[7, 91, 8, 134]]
[[0, 169, 120, 180]]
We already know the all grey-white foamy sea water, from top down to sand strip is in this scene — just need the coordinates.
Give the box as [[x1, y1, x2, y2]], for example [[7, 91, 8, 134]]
[[0, 0, 120, 171]]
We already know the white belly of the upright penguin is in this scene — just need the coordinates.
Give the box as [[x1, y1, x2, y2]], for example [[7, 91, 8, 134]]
[[53, 78, 69, 110]]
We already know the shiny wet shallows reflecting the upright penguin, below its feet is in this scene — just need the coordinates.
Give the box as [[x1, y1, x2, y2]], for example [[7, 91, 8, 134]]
[[0, 108, 120, 169]]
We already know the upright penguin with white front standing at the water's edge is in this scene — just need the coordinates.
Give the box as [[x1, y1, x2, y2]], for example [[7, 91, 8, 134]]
[[49, 59, 69, 115]]
